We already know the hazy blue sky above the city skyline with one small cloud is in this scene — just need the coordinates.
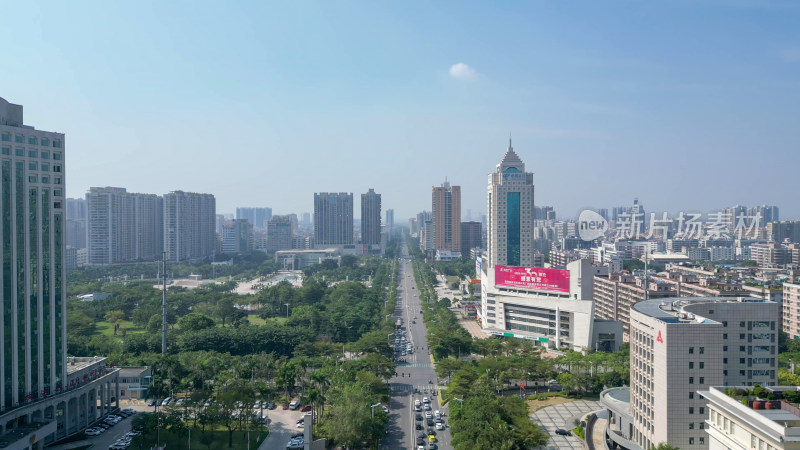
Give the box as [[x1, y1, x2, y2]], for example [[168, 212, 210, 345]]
[[0, 0, 800, 220]]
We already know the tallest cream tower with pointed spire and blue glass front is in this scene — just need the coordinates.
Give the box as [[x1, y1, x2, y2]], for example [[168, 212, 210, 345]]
[[487, 140, 534, 267]]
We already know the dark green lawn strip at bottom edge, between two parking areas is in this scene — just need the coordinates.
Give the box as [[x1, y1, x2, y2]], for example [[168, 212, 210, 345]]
[[130, 428, 269, 450]]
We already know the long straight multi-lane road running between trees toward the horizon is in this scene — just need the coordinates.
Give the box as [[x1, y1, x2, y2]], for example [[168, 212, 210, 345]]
[[382, 249, 453, 450]]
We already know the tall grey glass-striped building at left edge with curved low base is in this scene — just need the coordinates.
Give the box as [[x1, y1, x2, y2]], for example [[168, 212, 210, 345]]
[[0, 98, 119, 449]]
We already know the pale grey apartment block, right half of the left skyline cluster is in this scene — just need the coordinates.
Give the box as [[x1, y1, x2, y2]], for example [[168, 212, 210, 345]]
[[164, 191, 217, 262]]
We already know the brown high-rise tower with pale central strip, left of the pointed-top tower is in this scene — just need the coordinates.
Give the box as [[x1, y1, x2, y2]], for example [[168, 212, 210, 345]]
[[431, 181, 461, 252]]
